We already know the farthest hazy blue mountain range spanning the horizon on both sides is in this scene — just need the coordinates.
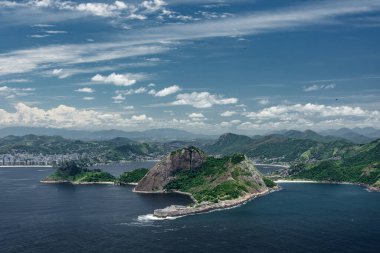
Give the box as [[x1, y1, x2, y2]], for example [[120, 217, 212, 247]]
[[0, 127, 380, 144]]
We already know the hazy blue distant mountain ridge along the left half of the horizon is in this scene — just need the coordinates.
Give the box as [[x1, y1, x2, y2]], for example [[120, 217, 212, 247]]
[[0, 127, 217, 142]]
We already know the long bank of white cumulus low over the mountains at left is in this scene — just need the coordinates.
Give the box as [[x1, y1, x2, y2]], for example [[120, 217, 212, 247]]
[[0, 103, 153, 129]]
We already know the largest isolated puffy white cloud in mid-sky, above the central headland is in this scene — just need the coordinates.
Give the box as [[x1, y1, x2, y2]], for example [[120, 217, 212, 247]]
[[172, 92, 238, 108]]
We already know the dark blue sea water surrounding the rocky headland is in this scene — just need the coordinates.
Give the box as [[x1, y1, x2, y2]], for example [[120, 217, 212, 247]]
[[0, 165, 380, 253]]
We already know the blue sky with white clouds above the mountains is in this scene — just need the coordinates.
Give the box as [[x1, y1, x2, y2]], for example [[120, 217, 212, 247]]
[[0, 0, 380, 135]]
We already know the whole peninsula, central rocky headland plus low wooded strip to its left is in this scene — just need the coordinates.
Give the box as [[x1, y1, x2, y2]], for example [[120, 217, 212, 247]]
[[41, 146, 277, 218]]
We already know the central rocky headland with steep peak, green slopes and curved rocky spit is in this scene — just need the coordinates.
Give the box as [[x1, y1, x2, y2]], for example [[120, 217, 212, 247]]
[[134, 146, 276, 218]]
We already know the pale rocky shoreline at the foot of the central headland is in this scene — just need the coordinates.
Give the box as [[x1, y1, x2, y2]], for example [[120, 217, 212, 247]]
[[149, 187, 280, 218]]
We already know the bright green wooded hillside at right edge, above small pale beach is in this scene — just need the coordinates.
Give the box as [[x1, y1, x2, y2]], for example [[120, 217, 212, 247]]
[[291, 140, 380, 185]]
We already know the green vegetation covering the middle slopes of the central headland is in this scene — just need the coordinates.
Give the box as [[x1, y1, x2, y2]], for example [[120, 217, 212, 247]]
[[165, 154, 263, 202]]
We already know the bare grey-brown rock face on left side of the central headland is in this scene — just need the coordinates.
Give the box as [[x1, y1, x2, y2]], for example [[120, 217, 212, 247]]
[[135, 147, 207, 192]]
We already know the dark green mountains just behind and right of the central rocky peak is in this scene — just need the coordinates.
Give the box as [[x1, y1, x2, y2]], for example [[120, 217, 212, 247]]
[[203, 130, 355, 162]]
